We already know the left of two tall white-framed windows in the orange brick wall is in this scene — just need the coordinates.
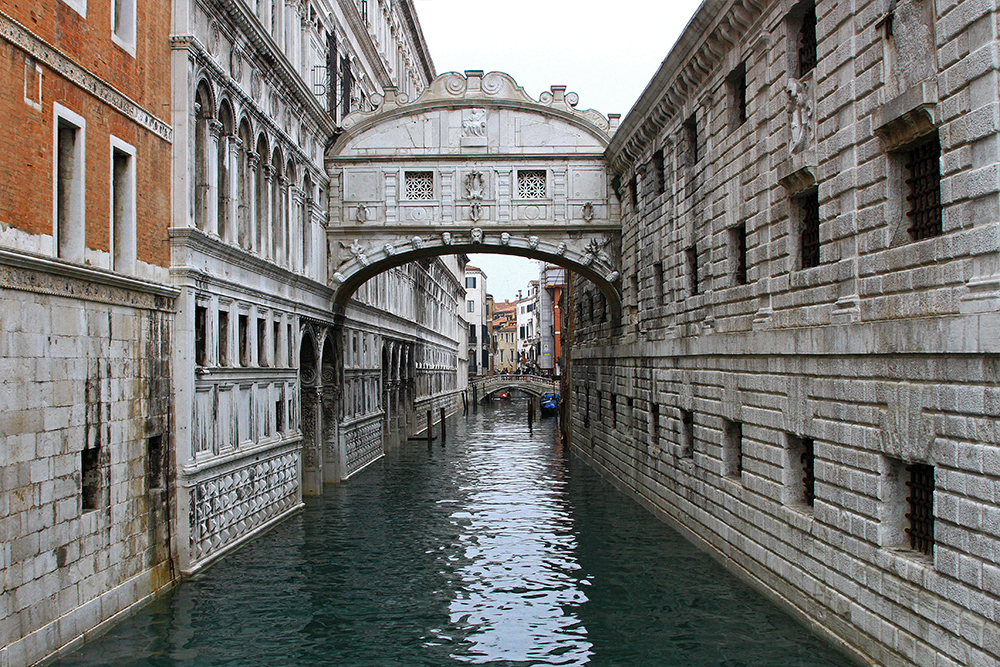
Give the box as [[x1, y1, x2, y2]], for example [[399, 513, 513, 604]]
[[52, 104, 86, 262]]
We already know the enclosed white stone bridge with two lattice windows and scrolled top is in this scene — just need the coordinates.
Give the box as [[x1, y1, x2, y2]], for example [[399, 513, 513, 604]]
[[326, 71, 621, 310]]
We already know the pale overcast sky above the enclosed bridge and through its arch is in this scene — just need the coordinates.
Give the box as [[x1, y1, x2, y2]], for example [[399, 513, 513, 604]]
[[414, 0, 701, 301]]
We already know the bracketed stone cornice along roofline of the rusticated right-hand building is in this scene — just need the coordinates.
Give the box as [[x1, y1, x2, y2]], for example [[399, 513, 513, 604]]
[[606, 0, 767, 174]]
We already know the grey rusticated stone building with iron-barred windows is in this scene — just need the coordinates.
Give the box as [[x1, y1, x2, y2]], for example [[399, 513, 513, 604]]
[[571, 0, 1000, 666]]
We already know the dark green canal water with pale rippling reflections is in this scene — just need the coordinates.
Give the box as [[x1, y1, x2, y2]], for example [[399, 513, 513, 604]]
[[56, 397, 854, 667]]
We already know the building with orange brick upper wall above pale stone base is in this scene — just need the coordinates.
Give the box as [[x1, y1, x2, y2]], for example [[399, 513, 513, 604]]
[[0, 0, 177, 667]]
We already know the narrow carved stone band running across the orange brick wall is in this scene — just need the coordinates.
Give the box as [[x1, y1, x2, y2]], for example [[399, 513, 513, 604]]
[[0, 12, 174, 142]]
